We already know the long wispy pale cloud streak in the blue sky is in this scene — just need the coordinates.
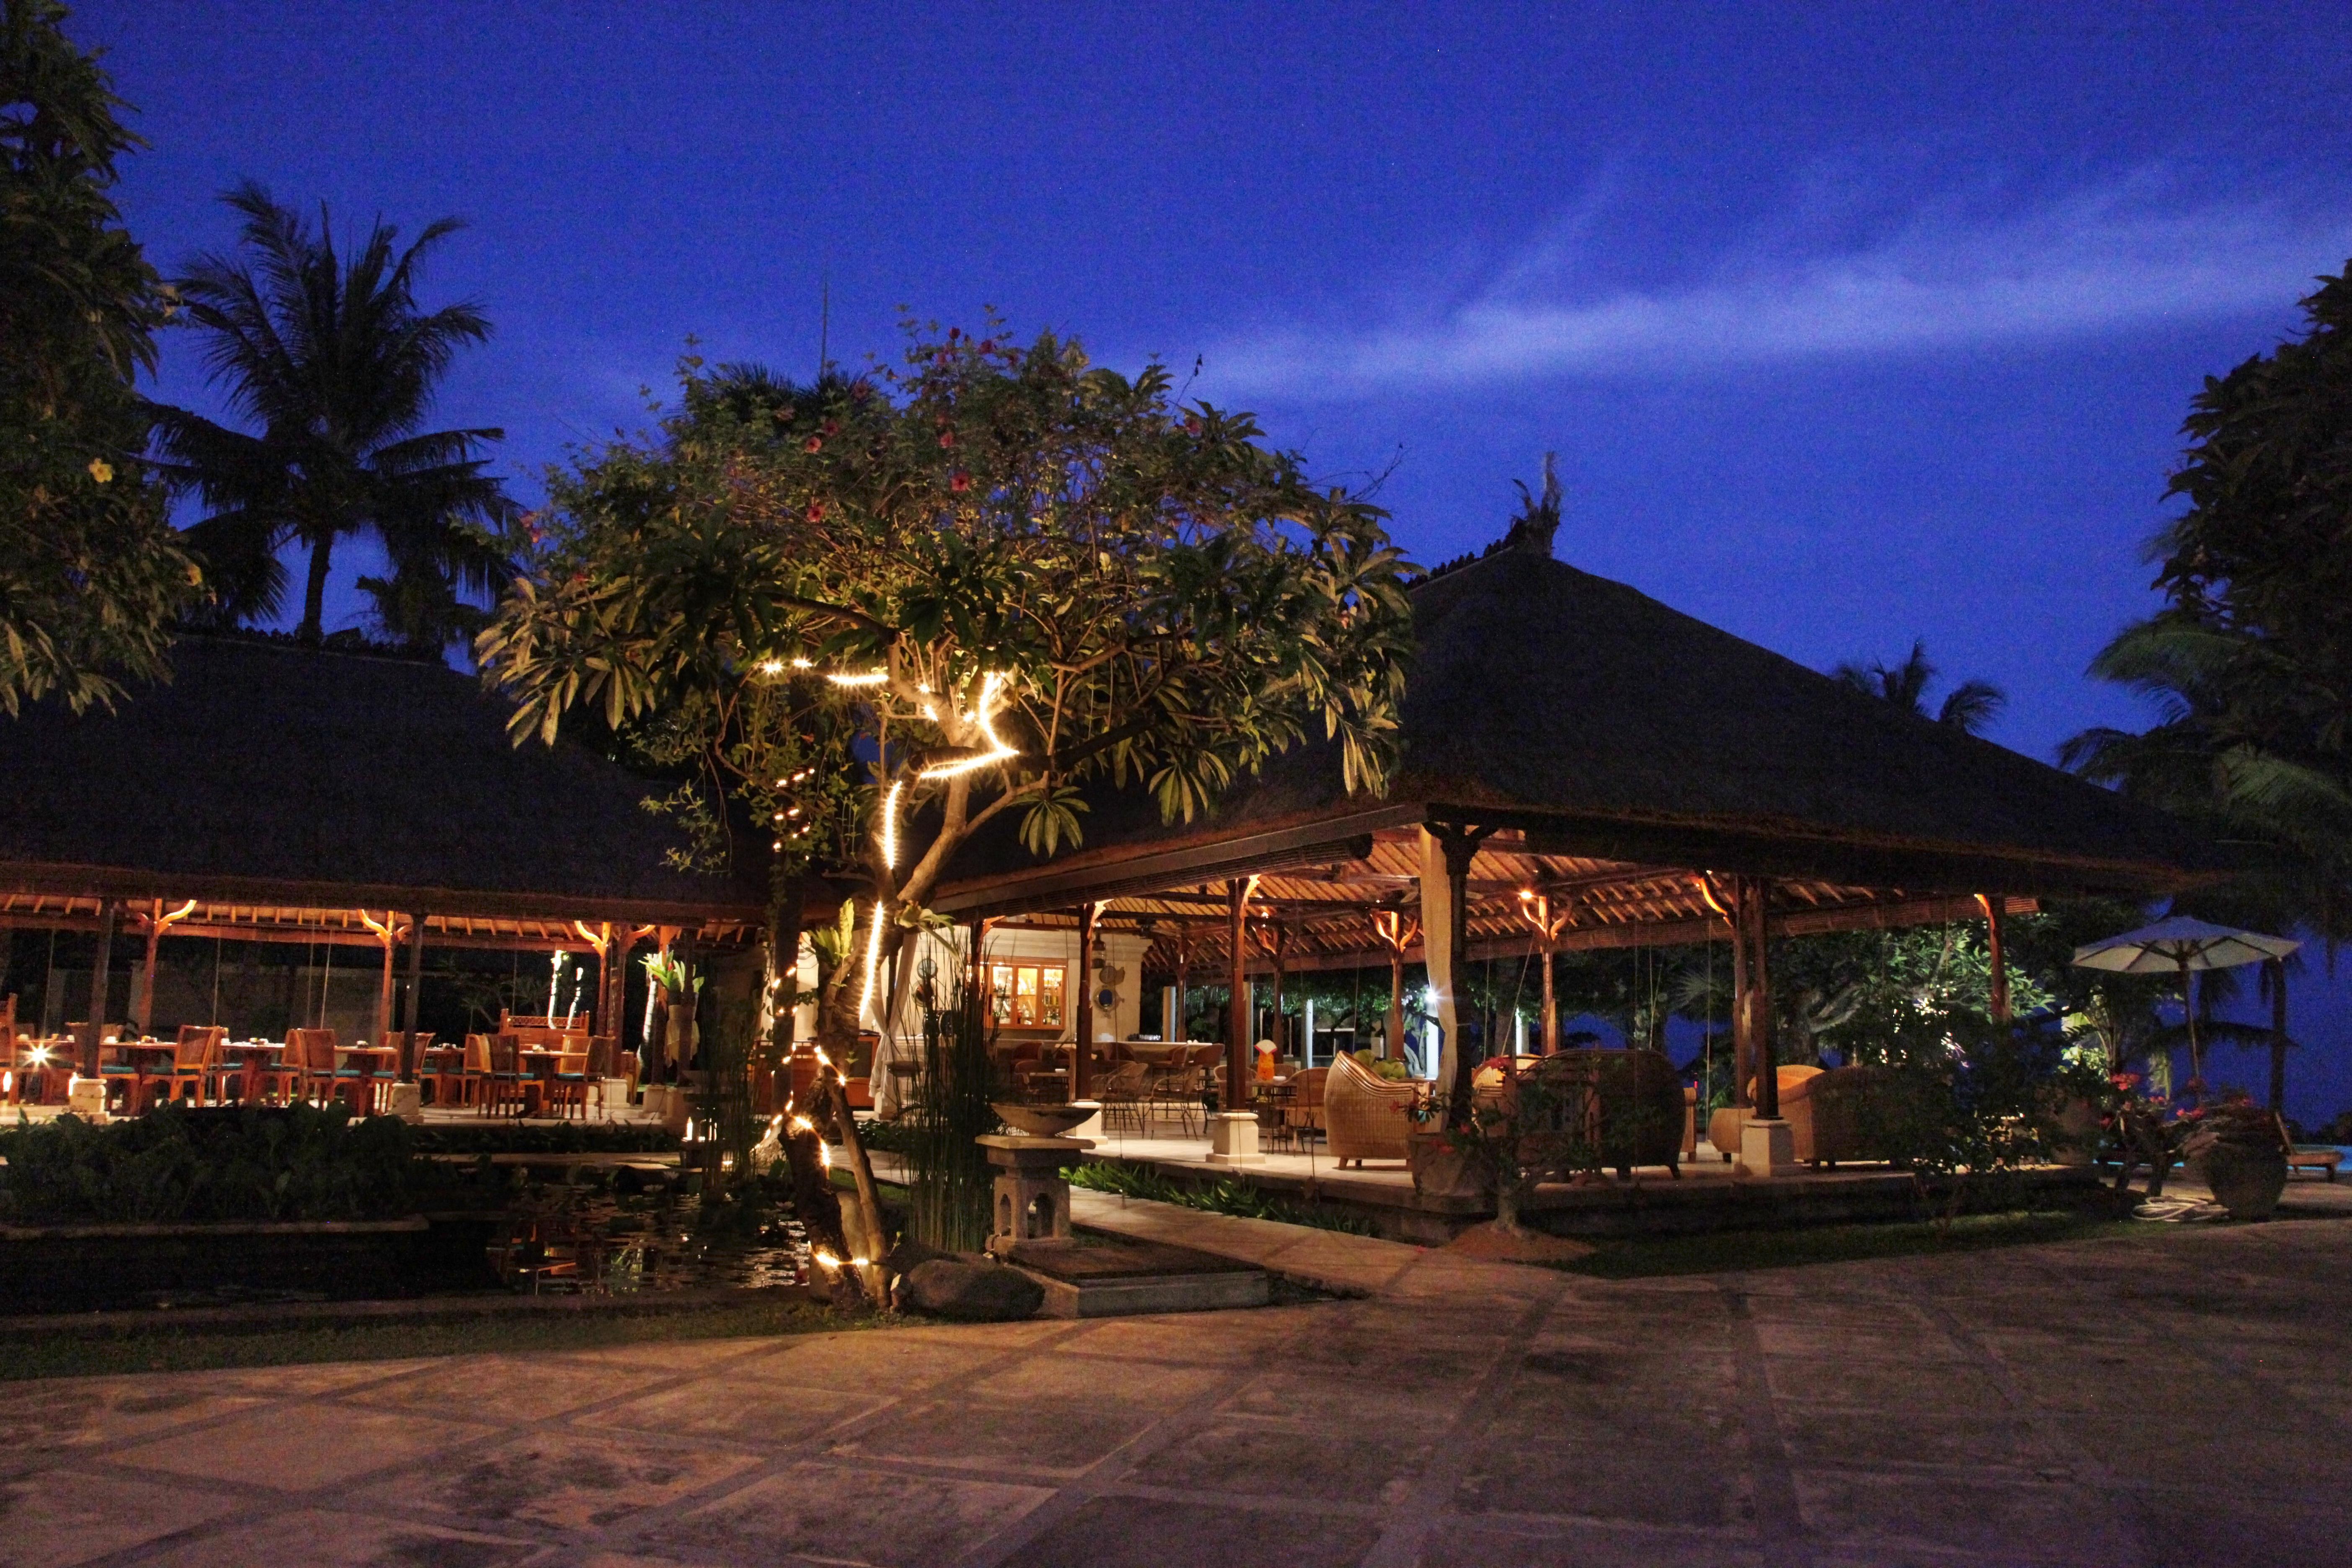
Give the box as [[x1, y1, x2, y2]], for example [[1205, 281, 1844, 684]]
[[1209, 179, 2352, 397]]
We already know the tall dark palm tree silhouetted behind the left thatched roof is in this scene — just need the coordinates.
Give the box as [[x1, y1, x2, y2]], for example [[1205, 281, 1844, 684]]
[[155, 181, 513, 642]]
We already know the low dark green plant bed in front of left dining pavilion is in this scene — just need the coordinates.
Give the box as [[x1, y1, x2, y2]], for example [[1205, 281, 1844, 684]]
[[0, 1105, 416, 1225]]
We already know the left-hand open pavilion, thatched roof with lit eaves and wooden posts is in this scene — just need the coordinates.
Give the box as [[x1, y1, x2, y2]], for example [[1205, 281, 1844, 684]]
[[0, 635, 764, 1100]]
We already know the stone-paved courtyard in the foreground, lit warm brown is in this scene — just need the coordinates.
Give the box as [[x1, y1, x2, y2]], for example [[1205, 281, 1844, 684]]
[[0, 1204, 2352, 1568]]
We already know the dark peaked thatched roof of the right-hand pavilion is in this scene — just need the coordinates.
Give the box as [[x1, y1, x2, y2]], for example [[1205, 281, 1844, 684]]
[[939, 545, 2215, 910]]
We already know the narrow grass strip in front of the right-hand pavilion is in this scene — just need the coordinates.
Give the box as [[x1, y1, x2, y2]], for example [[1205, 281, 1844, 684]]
[[1550, 1208, 2145, 1279]]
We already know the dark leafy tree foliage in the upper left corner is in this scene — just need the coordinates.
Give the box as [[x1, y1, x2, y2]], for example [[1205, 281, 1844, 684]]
[[0, 0, 202, 714]]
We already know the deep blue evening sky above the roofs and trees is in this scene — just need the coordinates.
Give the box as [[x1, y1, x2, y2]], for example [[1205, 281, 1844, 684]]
[[70, 0, 2352, 1128]]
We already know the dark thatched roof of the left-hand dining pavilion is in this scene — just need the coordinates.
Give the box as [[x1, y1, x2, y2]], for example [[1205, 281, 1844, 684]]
[[0, 637, 762, 924]]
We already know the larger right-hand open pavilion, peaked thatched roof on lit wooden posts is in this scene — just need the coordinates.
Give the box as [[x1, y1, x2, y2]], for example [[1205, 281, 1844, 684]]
[[934, 529, 2223, 1168]]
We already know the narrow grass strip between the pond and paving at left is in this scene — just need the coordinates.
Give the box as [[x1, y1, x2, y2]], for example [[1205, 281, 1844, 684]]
[[0, 1295, 873, 1380]]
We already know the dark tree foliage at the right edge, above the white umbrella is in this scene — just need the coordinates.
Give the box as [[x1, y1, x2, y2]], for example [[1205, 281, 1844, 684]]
[[2063, 262, 2352, 938]]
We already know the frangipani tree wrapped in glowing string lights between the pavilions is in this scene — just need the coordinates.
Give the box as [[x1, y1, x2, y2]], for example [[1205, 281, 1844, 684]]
[[477, 329, 1409, 1279]]
